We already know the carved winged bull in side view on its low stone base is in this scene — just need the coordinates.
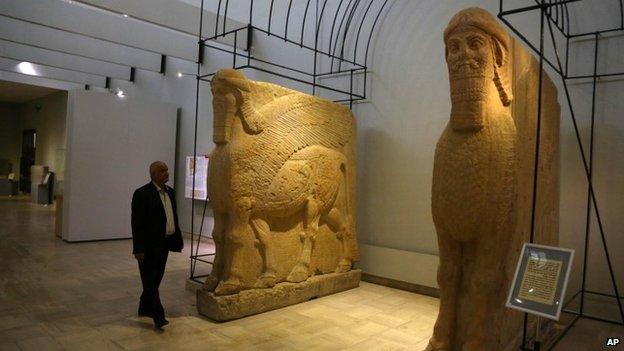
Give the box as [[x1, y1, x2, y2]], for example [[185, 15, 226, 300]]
[[197, 69, 361, 321]]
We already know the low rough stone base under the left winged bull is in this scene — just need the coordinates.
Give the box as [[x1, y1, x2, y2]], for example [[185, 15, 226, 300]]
[[197, 269, 362, 322]]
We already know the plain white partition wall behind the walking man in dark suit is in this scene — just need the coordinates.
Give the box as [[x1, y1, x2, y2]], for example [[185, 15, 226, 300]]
[[63, 90, 177, 241]]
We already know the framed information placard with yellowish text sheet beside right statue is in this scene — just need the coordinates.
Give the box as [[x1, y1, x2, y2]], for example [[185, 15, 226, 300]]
[[507, 243, 574, 320]]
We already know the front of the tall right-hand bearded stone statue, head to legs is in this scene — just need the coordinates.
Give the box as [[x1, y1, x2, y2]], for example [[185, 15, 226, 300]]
[[427, 8, 517, 351]]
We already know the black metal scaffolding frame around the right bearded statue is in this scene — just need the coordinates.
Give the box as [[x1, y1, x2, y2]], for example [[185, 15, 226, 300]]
[[498, 0, 624, 351]]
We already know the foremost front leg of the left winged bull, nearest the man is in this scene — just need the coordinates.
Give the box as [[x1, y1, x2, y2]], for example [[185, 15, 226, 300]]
[[215, 197, 253, 295]]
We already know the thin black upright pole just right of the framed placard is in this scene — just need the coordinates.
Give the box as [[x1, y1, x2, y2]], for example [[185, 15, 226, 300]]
[[580, 33, 598, 316]]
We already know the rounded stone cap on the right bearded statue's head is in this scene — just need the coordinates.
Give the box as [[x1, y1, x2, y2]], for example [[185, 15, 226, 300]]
[[444, 7, 509, 50]]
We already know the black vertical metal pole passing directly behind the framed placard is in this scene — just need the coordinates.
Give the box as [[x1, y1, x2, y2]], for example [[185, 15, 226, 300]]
[[522, 0, 545, 346]]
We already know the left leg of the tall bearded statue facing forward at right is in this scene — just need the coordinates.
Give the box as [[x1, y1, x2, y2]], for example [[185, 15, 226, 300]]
[[426, 234, 462, 351]]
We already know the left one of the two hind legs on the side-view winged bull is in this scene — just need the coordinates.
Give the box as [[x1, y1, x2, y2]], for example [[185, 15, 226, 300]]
[[286, 197, 321, 283]]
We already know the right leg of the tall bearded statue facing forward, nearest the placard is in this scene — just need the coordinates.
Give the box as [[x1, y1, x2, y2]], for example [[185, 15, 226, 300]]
[[461, 231, 507, 351]]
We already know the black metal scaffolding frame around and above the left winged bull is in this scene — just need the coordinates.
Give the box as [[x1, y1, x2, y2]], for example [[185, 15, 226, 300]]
[[189, 0, 392, 283]]
